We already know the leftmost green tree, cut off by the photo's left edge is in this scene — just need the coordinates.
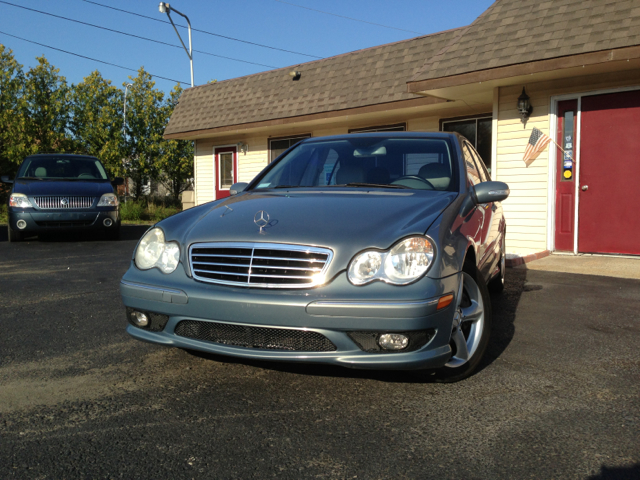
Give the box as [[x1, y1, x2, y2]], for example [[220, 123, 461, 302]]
[[0, 45, 28, 176]]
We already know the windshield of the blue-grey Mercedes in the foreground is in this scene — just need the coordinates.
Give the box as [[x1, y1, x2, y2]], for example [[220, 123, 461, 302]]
[[253, 136, 457, 190]]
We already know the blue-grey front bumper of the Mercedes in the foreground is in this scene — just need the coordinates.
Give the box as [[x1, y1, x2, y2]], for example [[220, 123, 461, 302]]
[[120, 265, 460, 370]]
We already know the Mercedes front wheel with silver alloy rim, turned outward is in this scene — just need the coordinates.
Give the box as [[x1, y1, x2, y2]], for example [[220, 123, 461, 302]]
[[435, 264, 491, 383]]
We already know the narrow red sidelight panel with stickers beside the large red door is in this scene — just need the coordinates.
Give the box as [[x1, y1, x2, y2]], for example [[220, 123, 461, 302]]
[[551, 100, 578, 252]]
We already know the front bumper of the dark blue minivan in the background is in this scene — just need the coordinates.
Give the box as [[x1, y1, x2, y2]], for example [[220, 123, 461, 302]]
[[9, 207, 120, 235]]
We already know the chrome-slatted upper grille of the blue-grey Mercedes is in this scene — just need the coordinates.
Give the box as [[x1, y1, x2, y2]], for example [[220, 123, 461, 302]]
[[189, 243, 333, 288]]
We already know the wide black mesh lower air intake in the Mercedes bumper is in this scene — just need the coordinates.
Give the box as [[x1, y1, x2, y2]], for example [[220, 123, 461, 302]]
[[175, 320, 336, 352]]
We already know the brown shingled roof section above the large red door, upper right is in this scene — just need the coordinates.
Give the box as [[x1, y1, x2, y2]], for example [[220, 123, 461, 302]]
[[411, 0, 640, 81]]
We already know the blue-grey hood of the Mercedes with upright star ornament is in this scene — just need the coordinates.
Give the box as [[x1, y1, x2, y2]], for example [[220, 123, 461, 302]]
[[160, 189, 457, 266]]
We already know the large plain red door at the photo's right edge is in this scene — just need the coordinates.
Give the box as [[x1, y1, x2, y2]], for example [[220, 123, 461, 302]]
[[578, 90, 640, 255]]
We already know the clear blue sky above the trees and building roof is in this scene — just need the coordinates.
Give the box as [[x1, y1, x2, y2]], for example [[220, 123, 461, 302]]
[[0, 0, 493, 92]]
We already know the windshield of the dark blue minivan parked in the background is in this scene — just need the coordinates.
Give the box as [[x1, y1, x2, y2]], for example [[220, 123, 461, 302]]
[[18, 156, 109, 181]]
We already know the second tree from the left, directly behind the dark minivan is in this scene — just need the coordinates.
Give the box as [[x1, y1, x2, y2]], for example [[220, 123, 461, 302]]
[[24, 55, 73, 153]]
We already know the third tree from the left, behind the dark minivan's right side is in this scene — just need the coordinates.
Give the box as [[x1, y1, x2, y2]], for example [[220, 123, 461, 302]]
[[69, 70, 125, 176]]
